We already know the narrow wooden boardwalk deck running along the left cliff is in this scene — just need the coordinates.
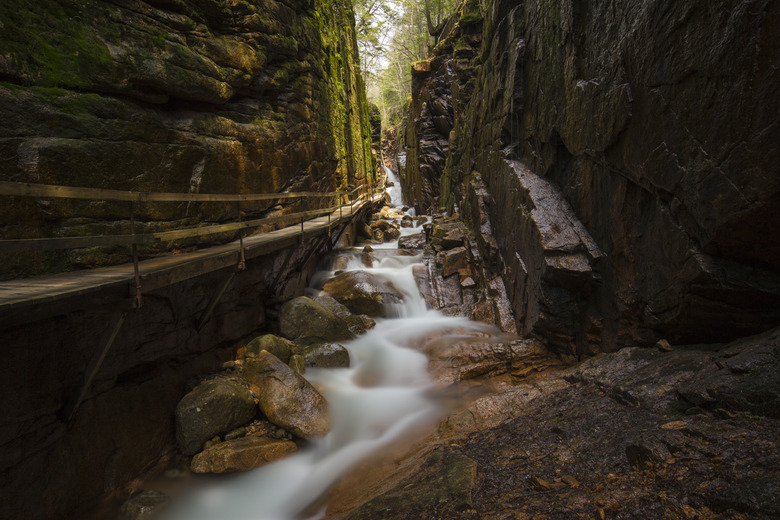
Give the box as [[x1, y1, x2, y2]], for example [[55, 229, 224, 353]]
[[0, 196, 380, 326]]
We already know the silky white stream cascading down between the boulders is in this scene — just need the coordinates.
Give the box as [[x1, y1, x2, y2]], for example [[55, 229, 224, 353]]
[[165, 172, 484, 520]]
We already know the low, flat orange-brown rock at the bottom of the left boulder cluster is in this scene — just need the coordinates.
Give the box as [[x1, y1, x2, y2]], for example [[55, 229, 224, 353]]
[[190, 437, 298, 473]]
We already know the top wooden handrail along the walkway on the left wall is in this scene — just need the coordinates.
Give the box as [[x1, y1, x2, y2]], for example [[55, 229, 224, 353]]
[[0, 181, 347, 202]]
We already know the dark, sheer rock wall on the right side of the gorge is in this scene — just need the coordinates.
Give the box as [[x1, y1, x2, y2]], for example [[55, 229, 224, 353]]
[[407, 0, 780, 353]]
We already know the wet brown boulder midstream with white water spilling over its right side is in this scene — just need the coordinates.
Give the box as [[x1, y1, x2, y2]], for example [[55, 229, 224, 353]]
[[323, 271, 403, 318]]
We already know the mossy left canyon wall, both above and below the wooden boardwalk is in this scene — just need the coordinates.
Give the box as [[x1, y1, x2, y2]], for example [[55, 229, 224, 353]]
[[0, 0, 374, 520]]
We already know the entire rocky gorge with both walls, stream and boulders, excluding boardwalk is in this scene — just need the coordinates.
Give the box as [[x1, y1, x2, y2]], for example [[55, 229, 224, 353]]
[[0, 0, 780, 520]]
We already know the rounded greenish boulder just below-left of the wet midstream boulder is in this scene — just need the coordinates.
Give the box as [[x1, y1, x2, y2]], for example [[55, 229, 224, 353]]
[[279, 294, 354, 341]]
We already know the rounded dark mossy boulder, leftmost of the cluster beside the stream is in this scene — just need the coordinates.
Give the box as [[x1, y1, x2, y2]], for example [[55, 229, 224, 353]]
[[176, 378, 256, 455]]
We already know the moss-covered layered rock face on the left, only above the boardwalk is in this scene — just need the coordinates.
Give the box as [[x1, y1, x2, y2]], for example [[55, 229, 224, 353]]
[[0, 0, 373, 276]]
